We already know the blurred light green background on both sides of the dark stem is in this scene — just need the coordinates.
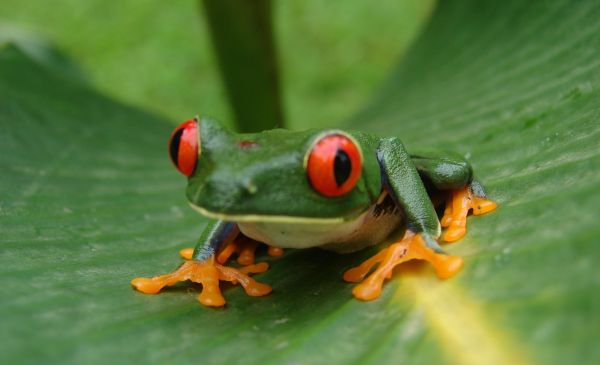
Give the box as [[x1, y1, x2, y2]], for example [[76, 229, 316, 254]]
[[0, 0, 433, 128]]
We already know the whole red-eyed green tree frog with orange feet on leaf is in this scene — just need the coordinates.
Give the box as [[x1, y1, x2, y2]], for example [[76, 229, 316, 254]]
[[131, 118, 496, 307]]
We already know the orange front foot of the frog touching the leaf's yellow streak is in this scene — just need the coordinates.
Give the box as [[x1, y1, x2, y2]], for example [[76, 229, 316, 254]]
[[344, 231, 463, 300]]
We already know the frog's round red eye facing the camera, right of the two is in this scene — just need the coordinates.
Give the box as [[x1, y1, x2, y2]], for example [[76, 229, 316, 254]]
[[306, 133, 362, 197]]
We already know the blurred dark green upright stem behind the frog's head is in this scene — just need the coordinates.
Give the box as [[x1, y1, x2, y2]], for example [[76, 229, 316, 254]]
[[202, 0, 284, 132]]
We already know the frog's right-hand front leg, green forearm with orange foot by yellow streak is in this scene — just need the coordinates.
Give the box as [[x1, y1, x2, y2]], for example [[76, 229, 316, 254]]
[[344, 138, 463, 300]]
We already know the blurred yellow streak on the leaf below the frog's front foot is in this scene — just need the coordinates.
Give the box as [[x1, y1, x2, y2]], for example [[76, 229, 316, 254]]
[[396, 275, 527, 365]]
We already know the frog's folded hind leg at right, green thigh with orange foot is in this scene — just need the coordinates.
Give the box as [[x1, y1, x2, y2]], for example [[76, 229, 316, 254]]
[[411, 152, 496, 242]]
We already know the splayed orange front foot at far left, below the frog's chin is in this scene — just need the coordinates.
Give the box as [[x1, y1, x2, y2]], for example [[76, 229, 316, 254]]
[[131, 256, 271, 307]]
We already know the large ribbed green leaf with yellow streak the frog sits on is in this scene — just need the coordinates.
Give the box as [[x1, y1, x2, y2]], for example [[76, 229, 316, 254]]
[[0, 0, 600, 364]]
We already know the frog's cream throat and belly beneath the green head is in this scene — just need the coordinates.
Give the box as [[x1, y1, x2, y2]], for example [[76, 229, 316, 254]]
[[238, 196, 402, 253]]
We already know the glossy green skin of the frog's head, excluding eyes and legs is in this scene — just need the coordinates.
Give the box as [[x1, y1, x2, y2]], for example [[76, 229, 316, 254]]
[[187, 118, 381, 218]]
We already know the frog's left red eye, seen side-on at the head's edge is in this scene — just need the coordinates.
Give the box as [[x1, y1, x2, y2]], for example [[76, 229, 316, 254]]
[[169, 119, 198, 176]]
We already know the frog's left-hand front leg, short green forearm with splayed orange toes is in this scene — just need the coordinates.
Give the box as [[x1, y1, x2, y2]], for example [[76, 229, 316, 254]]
[[131, 221, 271, 307]]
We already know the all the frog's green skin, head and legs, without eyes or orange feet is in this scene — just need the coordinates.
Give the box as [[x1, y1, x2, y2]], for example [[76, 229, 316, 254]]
[[187, 118, 483, 260]]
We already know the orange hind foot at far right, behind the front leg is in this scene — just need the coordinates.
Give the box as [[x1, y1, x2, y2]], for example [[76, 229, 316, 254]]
[[440, 187, 496, 242]]
